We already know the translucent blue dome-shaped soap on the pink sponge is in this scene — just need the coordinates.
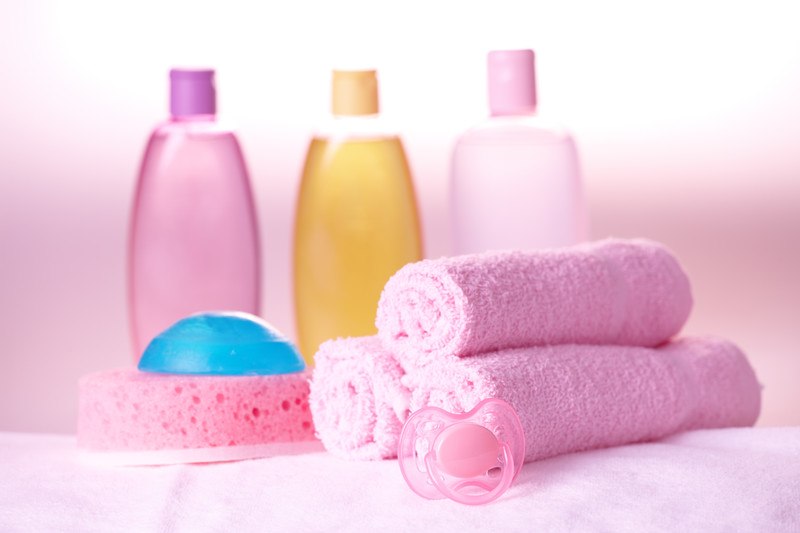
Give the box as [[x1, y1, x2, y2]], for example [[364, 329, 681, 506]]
[[139, 312, 306, 376]]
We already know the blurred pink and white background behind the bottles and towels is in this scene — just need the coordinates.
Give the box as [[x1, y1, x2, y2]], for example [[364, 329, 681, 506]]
[[0, 0, 800, 432]]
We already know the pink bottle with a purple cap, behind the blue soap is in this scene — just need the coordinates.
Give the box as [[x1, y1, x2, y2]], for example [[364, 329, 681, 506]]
[[128, 70, 260, 360]]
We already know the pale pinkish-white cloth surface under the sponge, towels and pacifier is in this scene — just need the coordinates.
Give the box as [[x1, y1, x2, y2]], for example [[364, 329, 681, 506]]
[[0, 427, 800, 533]]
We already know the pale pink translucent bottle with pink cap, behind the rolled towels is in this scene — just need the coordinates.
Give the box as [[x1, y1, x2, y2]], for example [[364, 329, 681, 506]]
[[450, 50, 587, 254]]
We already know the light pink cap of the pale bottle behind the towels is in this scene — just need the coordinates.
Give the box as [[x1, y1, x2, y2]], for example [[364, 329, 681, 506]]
[[489, 50, 536, 116]]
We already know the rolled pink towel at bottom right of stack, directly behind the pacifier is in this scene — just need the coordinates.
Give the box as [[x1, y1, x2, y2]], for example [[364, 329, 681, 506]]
[[405, 337, 761, 461]]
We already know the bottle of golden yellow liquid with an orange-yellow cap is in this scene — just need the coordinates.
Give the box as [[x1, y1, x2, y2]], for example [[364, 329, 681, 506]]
[[294, 70, 422, 365]]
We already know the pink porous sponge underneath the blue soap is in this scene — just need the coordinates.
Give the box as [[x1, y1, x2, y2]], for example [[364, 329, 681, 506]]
[[78, 369, 319, 464]]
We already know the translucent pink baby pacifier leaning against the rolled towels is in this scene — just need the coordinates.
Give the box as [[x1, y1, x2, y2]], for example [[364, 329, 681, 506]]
[[397, 398, 525, 505]]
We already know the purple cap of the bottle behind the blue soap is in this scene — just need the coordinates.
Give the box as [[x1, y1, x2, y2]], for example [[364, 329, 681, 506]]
[[169, 68, 217, 117]]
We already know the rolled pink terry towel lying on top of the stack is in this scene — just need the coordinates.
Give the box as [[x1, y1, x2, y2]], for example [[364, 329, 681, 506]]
[[376, 239, 692, 367]]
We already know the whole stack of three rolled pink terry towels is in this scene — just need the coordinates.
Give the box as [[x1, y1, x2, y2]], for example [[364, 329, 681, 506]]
[[309, 240, 761, 461]]
